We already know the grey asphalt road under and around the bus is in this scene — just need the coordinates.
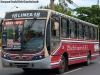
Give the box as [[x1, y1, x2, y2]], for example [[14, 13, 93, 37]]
[[0, 56, 100, 75]]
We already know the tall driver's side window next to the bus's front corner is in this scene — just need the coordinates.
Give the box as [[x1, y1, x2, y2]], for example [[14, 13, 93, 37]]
[[51, 17, 60, 52]]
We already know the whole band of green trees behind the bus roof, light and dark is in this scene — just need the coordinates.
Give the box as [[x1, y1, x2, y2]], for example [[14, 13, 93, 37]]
[[39, 4, 100, 39]]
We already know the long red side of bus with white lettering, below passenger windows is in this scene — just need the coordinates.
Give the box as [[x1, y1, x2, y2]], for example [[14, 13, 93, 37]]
[[51, 40, 98, 65]]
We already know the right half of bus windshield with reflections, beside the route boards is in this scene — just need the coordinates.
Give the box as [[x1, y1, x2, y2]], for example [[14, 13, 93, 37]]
[[22, 20, 45, 51]]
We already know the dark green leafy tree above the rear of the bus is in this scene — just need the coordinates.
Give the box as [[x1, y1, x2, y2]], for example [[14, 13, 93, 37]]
[[74, 5, 100, 25]]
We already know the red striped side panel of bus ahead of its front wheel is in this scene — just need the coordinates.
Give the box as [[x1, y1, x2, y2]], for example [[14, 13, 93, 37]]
[[51, 43, 67, 68]]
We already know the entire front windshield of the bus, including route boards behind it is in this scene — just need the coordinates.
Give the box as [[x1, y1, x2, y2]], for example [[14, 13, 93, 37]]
[[3, 19, 46, 52]]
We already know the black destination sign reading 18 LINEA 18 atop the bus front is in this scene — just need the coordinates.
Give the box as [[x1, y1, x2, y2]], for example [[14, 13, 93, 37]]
[[5, 10, 47, 19]]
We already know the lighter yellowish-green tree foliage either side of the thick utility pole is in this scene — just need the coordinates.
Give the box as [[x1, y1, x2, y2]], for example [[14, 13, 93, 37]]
[[39, 4, 72, 16]]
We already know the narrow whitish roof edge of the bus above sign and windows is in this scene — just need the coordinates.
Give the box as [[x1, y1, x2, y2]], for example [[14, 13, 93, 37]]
[[6, 8, 98, 27]]
